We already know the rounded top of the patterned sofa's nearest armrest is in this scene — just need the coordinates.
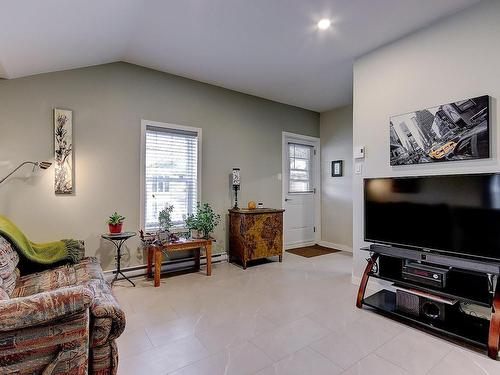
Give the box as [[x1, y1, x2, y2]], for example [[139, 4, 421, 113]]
[[0, 286, 93, 332]]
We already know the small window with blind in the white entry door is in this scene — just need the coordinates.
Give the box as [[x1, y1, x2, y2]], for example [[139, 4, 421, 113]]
[[288, 143, 313, 193]]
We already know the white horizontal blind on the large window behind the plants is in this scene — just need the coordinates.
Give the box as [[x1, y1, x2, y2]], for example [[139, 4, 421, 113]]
[[144, 125, 198, 230]]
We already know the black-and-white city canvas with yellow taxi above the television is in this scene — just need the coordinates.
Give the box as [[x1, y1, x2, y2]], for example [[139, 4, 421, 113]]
[[390, 95, 490, 166]]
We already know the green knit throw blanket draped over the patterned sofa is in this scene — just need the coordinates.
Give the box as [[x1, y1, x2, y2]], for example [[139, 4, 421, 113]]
[[0, 215, 85, 264]]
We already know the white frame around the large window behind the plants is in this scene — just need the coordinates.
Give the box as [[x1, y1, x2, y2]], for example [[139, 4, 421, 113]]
[[139, 119, 203, 231]]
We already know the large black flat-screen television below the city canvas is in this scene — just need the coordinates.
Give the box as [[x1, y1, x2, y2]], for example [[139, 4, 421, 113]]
[[364, 174, 500, 260]]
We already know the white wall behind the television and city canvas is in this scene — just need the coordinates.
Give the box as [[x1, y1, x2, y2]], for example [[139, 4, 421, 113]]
[[353, 1, 500, 277]]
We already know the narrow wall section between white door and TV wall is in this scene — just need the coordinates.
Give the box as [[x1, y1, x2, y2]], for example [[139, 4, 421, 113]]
[[320, 105, 352, 251]]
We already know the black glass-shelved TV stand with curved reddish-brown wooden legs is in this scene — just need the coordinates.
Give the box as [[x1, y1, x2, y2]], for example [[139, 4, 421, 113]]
[[356, 245, 500, 359]]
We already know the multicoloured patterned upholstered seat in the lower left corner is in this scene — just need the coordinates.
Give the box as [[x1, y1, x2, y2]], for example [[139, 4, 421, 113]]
[[0, 236, 125, 375]]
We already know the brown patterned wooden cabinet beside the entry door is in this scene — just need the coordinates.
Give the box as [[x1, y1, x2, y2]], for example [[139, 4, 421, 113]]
[[229, 208, 285, 269]]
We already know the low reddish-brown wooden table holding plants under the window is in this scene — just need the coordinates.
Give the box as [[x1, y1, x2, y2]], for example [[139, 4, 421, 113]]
[[146, 239, 212, 287]]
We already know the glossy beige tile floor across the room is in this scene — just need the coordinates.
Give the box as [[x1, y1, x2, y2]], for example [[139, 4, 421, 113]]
[[114, 253, 500, 375]]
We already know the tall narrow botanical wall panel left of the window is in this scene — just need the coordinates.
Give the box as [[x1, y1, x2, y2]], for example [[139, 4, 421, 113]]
[[54, 108, 73, 194]]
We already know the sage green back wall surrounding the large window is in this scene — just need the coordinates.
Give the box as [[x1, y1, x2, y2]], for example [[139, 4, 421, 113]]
[[0, 63, 319, 269]]
